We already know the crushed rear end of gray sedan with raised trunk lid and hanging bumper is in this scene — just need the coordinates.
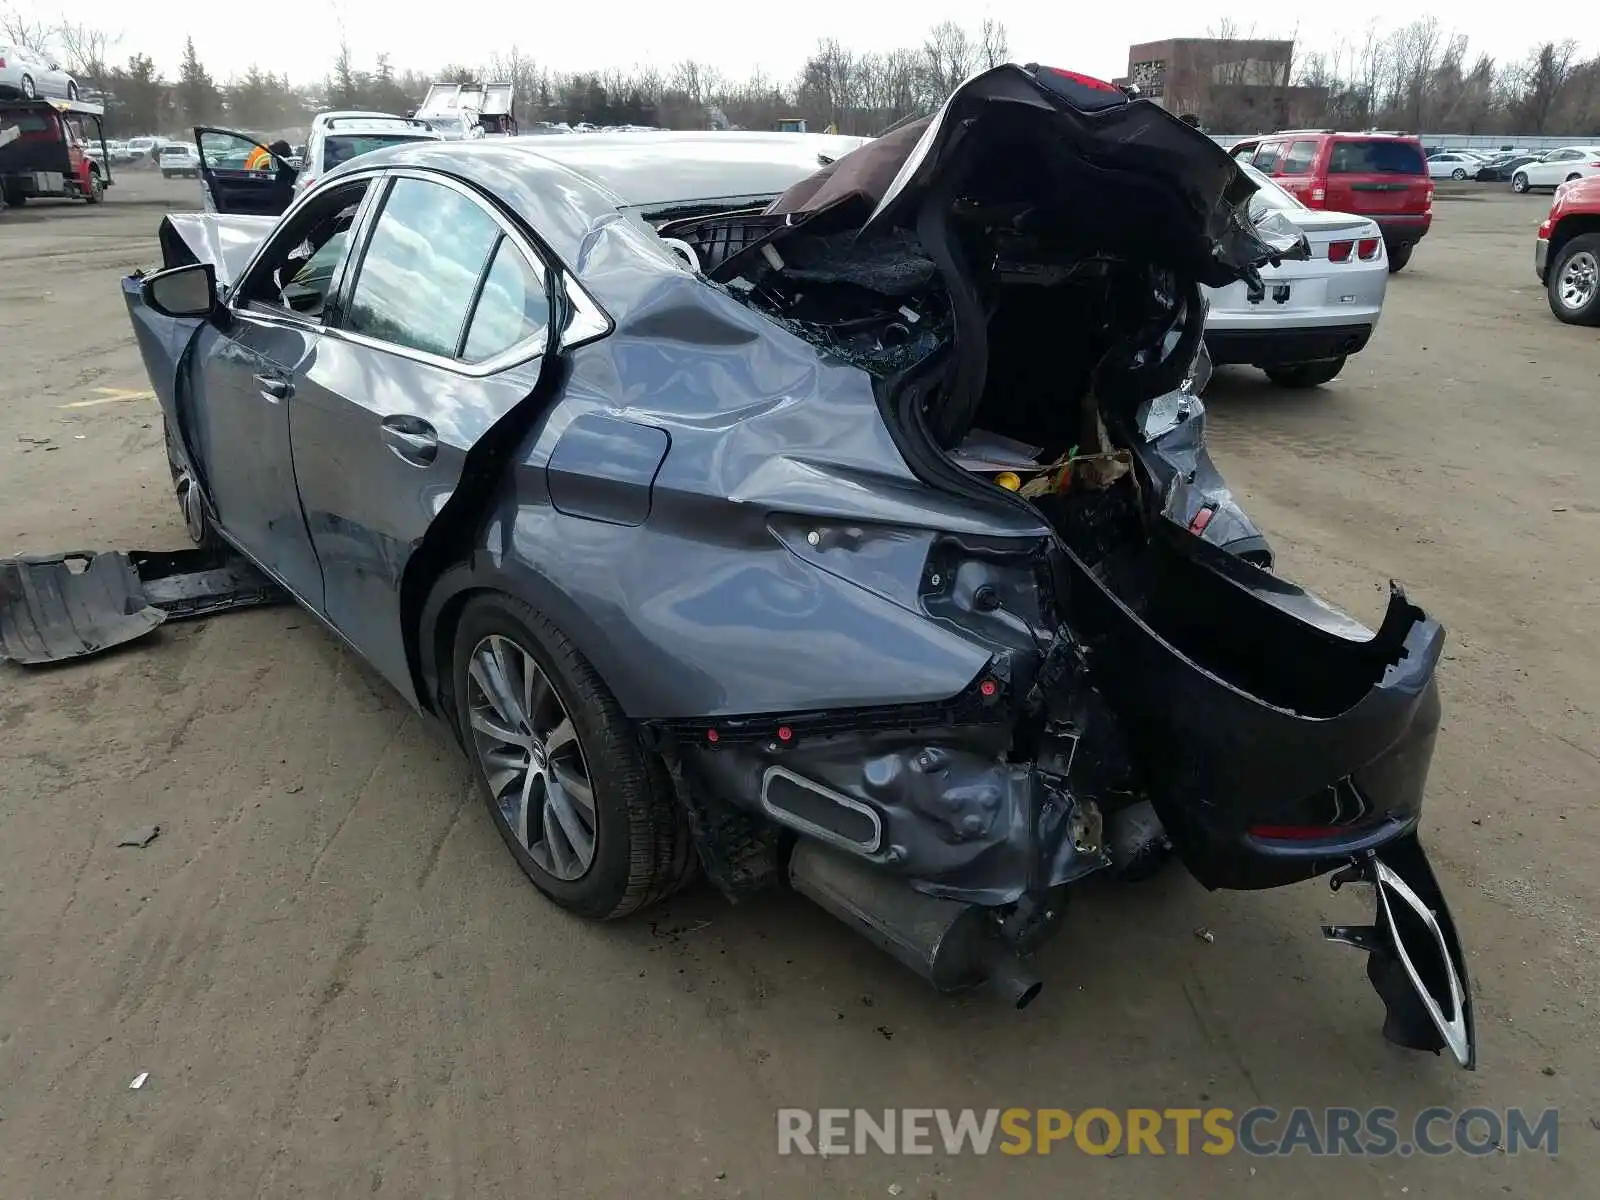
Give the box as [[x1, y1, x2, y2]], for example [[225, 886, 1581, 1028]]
[[651, 67, 1474, 1066]]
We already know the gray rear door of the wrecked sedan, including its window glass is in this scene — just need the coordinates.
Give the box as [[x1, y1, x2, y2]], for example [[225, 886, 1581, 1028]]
[[291, 170, 557, 699]]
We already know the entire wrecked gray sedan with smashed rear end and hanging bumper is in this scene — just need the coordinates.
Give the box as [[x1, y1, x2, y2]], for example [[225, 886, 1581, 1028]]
[[125, 66, 1474, 1066]]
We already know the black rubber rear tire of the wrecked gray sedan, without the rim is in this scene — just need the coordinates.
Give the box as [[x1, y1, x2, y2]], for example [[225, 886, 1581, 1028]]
[[451, 592, 699, 920]]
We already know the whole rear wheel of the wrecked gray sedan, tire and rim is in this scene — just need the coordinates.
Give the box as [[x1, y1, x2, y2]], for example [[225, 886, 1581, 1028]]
[[453, 594, 698, 920]]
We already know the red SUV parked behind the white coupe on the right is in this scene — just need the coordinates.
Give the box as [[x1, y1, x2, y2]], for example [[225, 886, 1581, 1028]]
[[1230, 130, 1434, 272]]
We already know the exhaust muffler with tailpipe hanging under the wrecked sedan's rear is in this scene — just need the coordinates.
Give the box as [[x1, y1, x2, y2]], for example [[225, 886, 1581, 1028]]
[[789, 838, 1045, 1010]]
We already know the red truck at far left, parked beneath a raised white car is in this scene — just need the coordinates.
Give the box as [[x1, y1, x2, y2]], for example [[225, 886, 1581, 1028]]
[[0, 99, 112, 205]]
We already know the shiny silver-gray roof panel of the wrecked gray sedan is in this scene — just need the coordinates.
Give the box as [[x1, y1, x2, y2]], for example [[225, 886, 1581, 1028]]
[[322, 130, 867, 274]]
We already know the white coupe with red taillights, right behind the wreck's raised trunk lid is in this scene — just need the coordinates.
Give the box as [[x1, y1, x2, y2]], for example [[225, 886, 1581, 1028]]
[[1205, 163, 1389, 387]]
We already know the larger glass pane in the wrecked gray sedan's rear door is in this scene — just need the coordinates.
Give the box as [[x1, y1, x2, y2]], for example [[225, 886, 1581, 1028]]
[[344, 179, 501, 358]]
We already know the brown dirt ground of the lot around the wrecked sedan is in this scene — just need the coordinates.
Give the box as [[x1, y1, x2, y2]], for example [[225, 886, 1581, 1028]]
[[0, 174, 1600, 1200]]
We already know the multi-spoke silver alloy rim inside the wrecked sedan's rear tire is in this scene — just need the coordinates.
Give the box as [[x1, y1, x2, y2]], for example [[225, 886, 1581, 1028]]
[[467, 634, 595, 882]]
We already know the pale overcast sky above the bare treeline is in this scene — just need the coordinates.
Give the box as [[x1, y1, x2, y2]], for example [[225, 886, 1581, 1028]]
[[0, 0, 1600, 82]]
